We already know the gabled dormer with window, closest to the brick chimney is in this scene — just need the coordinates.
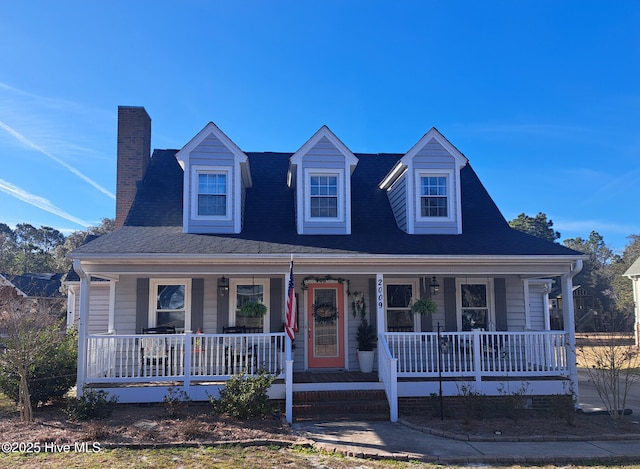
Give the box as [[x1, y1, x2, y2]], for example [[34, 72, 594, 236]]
[[176, 122, 251, 233]]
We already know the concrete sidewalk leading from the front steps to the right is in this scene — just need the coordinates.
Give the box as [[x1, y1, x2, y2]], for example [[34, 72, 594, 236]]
[[293, 421, 640, 464]]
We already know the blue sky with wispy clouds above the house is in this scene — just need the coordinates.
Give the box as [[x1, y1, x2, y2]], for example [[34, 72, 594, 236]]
[[0, 0, 640, 250]]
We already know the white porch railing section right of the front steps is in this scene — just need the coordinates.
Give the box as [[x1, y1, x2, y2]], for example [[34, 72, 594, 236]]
[[383, 331, 569, 381]]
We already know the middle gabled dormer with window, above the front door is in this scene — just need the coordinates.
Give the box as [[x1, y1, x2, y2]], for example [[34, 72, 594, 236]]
[[287, 126, 358, 235]]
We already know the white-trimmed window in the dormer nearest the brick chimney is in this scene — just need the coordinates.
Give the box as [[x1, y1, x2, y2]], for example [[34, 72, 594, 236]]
[[191, 166, 231, 220]]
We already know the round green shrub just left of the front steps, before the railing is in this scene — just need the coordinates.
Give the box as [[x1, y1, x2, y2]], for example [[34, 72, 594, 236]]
[[209, 370, 275, 419]]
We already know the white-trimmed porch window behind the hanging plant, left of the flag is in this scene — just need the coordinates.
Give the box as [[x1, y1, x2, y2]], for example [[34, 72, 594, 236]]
[[229, 279, 269, 332]]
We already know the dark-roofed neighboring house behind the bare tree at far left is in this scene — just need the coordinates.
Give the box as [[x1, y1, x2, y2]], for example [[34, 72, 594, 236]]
[[0, 272, 67, 318]]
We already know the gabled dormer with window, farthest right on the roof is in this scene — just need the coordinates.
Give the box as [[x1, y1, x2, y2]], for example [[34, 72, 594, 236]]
[[380, 127, 467, 234]]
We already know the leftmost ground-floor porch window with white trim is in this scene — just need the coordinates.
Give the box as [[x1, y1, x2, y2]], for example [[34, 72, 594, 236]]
[[149, 279, 191, 332]]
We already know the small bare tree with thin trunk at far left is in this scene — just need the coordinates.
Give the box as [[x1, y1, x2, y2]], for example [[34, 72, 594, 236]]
[[0, 287, 62, 422]]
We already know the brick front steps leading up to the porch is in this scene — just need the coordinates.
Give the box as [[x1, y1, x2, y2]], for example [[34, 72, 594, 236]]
[[293, 390, 389, 421]]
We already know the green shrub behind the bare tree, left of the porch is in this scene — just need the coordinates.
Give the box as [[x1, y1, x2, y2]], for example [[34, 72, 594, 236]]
[[0, 332, 78, 405]]
